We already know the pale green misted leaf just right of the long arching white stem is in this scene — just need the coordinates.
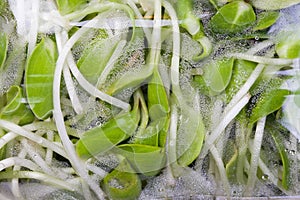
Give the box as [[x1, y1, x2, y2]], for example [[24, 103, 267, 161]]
[[77, 34, 120, 85]]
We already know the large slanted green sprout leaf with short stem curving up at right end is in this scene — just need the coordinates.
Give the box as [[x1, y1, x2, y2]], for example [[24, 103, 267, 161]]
[[76, 93, 140, 159]]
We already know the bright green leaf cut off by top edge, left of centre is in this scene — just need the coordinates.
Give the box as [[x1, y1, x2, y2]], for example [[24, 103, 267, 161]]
[[56, 0, 88, 15]]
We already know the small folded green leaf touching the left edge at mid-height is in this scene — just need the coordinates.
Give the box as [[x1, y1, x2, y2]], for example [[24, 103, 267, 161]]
[[0, 86, 34, 125]]
